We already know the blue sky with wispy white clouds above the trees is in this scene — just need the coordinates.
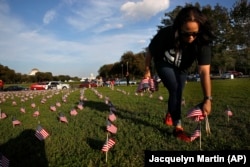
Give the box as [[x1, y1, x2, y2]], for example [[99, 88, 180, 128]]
[[0, 0, 236, 78]]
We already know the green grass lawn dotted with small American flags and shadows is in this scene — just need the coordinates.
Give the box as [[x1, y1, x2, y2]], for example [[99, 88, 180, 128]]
[[0, 79, 250, 167]]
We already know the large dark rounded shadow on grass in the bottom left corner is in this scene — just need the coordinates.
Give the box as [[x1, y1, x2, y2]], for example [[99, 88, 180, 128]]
[[0, 129, 48, 167]]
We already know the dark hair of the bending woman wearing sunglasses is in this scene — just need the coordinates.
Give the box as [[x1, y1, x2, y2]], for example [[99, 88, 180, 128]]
[[173, 6, 215, 45]]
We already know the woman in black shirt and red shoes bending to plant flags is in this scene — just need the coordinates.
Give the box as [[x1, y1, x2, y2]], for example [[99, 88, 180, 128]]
[[144, 6, 215, 142]]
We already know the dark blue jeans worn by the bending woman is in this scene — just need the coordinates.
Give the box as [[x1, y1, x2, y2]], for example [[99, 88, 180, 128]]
[[155, 61, 187, 126]]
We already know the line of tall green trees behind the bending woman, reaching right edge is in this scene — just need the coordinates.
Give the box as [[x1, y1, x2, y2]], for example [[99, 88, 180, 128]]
[[98, 0, 250, 78]]
